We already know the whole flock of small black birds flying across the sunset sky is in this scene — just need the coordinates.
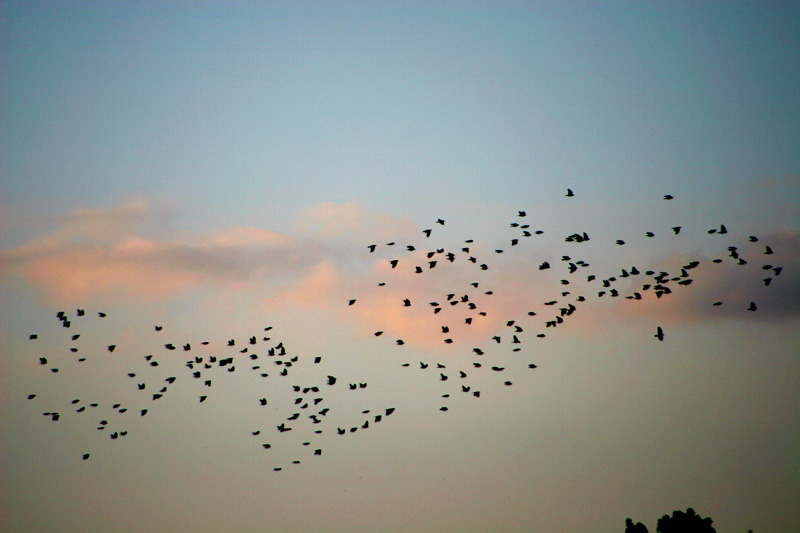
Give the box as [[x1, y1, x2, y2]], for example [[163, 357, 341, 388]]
[[20, 189, 782, 471]]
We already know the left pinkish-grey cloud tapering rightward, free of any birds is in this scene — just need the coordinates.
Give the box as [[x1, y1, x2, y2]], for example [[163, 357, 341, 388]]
[[0, 203, 323, 301]]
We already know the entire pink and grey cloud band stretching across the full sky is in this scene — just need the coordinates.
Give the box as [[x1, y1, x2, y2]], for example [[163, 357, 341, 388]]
[[0, 197, 800, 350]]
